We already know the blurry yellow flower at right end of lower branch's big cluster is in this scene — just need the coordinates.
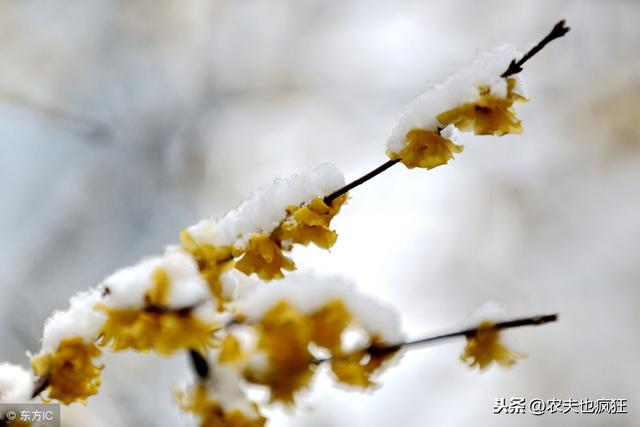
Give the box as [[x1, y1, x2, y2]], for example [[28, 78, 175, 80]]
[[331, 338, 400, 388]]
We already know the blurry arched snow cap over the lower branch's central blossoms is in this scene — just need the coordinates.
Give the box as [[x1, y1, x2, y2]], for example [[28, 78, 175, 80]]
[[237, 272, 403, 343]]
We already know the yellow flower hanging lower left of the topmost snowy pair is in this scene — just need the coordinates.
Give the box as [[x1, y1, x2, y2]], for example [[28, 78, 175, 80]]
[[387, 129, 464, 169]]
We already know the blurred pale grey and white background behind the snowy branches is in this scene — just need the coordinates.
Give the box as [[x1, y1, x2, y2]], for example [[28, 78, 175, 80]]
[[0, 0, 640, 427]]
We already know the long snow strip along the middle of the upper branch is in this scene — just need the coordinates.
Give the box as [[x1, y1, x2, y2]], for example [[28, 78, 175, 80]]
[[187, 163, 344, 249]]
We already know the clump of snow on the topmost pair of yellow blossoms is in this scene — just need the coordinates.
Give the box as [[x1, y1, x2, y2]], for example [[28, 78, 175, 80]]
[[387, 44, 525, 153]]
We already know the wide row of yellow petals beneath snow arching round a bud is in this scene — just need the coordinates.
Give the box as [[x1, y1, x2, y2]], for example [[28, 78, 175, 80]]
[[96, 304, 218, 355]]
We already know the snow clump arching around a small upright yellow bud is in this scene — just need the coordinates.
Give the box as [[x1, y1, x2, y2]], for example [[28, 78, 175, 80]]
[[100, 246, 210, 310]]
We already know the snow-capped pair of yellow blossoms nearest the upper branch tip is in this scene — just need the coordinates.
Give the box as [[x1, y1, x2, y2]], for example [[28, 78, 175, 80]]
[[387, 45, 526, 169]]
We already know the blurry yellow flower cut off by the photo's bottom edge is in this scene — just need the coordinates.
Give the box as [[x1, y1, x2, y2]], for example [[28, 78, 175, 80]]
[[178, 385, 267, 427]]
